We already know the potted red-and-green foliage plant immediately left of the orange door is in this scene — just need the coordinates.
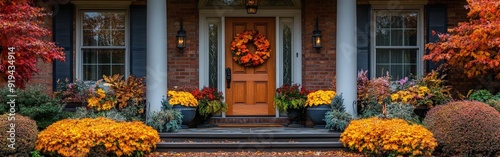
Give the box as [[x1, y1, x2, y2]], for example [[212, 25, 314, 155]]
[[191, 87, 227, 127]]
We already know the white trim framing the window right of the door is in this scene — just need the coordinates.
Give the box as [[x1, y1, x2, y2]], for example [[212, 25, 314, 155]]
[[370, 4, 427, 78]]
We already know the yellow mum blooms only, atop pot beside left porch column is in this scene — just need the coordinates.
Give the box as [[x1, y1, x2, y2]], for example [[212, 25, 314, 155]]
[[167, 90, 198, 107]]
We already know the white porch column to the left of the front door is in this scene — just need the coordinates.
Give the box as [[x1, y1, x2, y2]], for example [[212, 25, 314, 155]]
[[146, 0, 167, 111]]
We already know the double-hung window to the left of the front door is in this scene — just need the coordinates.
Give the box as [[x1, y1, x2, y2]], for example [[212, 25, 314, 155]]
[[79, 9, 128, 81]]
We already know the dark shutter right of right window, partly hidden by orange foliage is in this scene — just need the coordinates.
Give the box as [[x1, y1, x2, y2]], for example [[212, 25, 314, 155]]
[[425, 5, 448, 72]]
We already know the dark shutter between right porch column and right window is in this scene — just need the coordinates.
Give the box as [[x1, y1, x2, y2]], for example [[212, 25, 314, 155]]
[[356, 5, 371, 76]]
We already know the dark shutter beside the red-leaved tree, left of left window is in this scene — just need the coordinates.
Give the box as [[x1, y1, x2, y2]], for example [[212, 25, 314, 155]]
[[52, 4, 75, 90]]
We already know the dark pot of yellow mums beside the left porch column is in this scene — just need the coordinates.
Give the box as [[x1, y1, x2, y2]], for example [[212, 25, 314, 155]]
[[167, 90, 198, 129]]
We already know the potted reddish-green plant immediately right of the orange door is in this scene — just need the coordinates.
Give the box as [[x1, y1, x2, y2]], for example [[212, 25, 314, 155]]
[[274, 84, 307, 127]]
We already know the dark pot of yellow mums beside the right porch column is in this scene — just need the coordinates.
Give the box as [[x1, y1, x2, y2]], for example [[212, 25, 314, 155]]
[[305, 90, 335, 128]]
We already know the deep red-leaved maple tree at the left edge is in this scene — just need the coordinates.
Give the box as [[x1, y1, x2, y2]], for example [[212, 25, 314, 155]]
[[0, 0, 65, 88]]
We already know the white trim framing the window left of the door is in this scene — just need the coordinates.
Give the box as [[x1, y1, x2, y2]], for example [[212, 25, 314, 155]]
[[72, 4, 130, 81]]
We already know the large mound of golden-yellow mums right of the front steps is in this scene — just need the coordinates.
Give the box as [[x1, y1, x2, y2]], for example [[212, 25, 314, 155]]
[[340, 117, 437, 156]]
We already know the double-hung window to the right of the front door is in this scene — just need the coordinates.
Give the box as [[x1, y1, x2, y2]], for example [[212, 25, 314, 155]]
[[372, 10, 423, 79]]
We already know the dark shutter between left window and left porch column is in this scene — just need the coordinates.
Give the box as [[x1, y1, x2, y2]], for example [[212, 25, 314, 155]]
[[130, 5, 147, 77]]
